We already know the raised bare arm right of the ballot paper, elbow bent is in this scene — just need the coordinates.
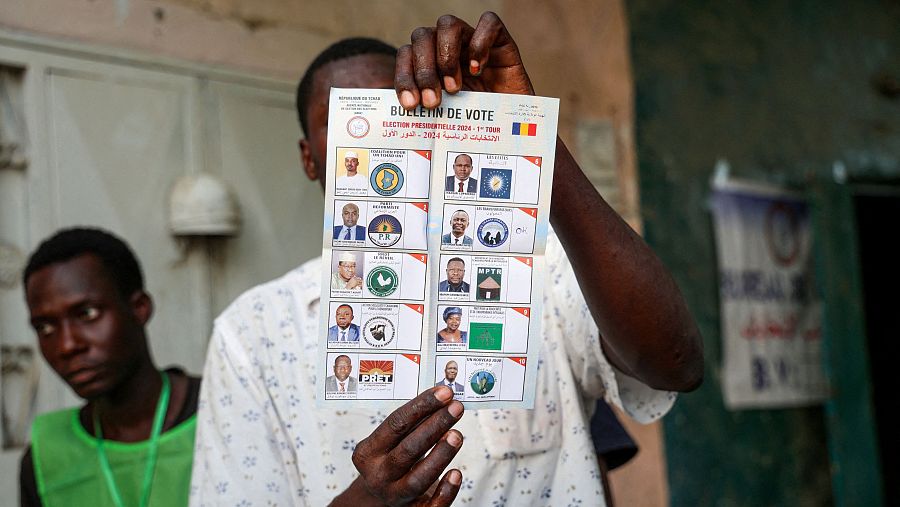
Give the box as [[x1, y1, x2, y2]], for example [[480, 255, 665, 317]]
[[550, 138, 703, 391]]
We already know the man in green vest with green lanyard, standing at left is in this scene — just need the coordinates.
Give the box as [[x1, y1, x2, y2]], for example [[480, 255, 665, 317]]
[[20, 228, 200, 507]]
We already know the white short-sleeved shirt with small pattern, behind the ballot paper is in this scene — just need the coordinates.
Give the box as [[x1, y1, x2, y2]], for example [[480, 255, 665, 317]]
[[191, 230, 675, 507]]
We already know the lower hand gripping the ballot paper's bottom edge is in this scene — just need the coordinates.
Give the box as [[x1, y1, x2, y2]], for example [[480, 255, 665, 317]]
[[332, 386, 463, 507]]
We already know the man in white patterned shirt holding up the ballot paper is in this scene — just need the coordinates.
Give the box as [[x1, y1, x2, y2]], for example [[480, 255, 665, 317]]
[[191, 12, 703, 506]]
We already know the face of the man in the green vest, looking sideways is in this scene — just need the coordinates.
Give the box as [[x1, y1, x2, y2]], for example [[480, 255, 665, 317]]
[[25, 254, 150, 399]]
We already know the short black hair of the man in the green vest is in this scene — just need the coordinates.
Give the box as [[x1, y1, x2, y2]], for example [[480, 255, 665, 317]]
[[22, 227, 144, 299]]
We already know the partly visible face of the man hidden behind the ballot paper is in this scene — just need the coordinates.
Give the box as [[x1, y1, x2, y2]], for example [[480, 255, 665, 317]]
[[300, 54, 394, 190]]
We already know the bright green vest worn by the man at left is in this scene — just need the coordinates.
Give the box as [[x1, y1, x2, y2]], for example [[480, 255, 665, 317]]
[[31, 408, 197, 507]]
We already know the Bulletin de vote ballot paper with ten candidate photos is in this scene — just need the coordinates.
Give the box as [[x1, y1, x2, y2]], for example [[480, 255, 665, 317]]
[[316, 88, 559, 409]]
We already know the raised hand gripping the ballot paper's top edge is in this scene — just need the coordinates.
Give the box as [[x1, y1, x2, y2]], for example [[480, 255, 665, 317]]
[[394, 12, 534, 109]]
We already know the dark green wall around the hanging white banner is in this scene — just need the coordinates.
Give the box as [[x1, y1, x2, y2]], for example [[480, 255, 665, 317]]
[[628, 0, 900, 506]]
